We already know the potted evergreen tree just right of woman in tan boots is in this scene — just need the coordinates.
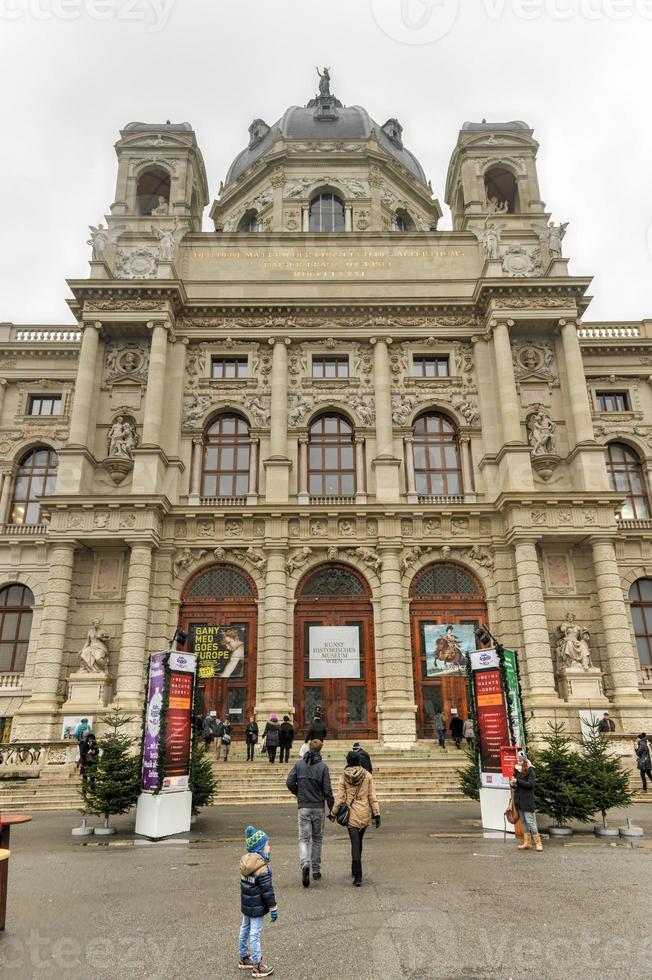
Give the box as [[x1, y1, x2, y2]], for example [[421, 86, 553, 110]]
[[532, 722, 595, 837]]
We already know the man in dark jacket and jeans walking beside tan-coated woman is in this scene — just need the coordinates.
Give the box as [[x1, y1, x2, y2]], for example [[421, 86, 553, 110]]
[[286, 738, 334, 888]]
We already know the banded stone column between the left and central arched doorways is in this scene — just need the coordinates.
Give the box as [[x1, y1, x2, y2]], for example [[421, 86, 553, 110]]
[[256, 547, 293, 718]]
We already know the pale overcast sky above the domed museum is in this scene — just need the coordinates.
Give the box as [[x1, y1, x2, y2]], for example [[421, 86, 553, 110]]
[[0, 0, 652, 323]]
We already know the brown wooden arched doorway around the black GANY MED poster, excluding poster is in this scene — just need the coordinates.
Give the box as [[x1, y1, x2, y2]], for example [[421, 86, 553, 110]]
[[179, 565, 258, 734]]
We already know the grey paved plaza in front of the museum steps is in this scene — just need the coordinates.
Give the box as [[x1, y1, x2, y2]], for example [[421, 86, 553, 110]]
[[0, 802, 652, 980]]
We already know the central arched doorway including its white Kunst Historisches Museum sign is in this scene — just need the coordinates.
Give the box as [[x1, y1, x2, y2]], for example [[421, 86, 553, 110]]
[[294, 563, 378, 739]]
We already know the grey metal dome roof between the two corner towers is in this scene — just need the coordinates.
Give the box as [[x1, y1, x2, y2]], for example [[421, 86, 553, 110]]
[[225, 87, 427, 184]]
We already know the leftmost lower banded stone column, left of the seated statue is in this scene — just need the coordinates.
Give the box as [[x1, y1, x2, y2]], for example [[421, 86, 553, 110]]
[[29, 541, 75, 714]]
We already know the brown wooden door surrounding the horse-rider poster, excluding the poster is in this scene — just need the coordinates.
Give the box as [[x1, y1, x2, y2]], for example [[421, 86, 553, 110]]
[[410, 564, 487, 738]]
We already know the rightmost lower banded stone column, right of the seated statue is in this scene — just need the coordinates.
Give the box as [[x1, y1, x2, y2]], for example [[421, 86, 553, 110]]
[[591, 539, 642, 702]]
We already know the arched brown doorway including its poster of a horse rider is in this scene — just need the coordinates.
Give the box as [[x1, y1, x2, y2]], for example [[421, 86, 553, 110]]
[[410, 562, 487, 738]]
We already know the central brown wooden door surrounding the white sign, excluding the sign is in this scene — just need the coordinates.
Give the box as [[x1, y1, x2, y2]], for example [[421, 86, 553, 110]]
[[294, 566, 378, 741]]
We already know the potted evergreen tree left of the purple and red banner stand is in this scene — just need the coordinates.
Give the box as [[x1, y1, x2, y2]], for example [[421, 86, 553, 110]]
[[82, 708, 141, 835]]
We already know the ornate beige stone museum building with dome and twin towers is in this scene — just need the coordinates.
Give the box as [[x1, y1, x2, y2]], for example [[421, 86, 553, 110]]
[[0, 78, 652, 746]]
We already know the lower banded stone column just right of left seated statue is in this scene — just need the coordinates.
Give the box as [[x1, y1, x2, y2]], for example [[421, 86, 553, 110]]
[[115, 542, 153, 711]]
